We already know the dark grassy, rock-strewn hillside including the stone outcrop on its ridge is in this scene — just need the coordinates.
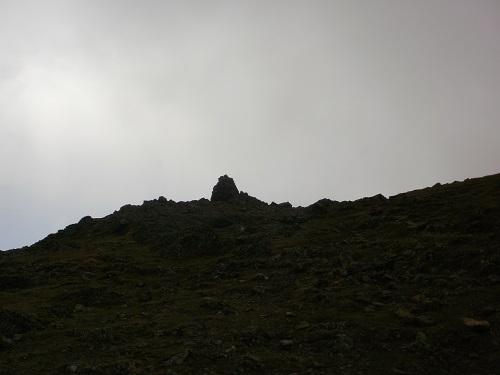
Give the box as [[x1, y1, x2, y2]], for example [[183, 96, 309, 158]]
[[0, 174, 500, 375]]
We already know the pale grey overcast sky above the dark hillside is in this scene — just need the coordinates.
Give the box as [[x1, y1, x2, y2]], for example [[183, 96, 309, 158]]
[[0, 0, 500, 250]]
